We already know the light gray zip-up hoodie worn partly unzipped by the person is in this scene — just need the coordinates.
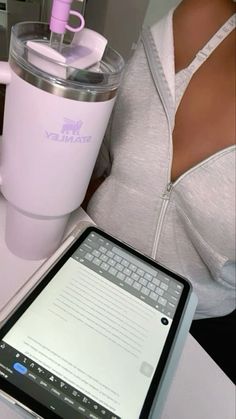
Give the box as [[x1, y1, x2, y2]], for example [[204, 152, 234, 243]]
[[88, 11, 235, 318]]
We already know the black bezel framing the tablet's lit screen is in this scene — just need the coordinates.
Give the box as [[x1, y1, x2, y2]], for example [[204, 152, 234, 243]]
[[0, 226, 192, 419]]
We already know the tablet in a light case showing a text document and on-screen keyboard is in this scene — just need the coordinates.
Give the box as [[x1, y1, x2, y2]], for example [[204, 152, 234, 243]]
[[0, 226, 196, 419]]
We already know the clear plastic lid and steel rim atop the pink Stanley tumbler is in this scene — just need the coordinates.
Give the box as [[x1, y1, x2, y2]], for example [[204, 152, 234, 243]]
[[9, 22, 125, 102]]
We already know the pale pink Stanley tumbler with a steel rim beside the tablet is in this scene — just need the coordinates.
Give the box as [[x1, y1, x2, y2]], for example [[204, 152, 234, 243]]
[[0, 22, 124, 259]]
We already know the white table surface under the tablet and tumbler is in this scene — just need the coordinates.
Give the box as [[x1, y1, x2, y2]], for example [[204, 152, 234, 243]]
[[0, 194, 236, 419]]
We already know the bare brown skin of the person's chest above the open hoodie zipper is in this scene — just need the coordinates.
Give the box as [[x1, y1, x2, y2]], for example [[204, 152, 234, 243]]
[[172, 0, 236, 181]]
